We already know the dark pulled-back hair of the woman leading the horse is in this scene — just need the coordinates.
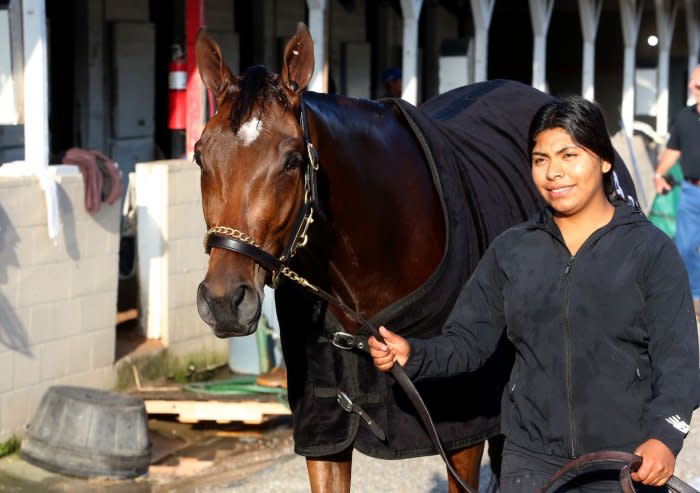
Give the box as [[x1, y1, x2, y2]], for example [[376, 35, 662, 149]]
[[527, 96, 616, 198]]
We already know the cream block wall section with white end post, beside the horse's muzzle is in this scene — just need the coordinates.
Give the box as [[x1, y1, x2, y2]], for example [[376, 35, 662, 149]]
[[136, 160, 228, 361]]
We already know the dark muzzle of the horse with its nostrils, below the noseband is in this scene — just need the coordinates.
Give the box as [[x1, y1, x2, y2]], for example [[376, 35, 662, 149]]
[[197, 282, 262, 338]]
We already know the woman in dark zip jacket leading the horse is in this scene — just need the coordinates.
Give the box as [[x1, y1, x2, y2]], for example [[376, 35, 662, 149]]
[[370, 97, 700, 493]]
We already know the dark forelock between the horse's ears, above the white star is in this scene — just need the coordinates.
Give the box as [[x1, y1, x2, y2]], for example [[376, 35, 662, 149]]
[[229, 65, 289, 132]]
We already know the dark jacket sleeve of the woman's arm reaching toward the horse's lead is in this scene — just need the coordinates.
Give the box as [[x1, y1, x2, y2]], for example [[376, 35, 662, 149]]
[[404, 244, 505, 379]]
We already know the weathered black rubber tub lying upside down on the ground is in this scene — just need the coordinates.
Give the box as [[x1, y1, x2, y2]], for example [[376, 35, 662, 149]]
[[20, 386, 151, 478]]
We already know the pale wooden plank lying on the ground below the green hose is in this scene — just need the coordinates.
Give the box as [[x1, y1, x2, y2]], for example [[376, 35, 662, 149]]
[[144, 399, 291, 424]]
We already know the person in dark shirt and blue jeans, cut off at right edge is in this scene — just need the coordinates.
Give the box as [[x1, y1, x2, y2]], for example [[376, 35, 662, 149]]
[[654, 66, 700, 316]]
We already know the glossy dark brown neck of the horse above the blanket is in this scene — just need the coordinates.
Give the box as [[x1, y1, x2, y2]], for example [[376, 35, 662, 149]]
[[304, 93, 445, 315]]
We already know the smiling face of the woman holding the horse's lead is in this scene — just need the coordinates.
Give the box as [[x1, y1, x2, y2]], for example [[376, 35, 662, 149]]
[[532, 128, 612, 216]]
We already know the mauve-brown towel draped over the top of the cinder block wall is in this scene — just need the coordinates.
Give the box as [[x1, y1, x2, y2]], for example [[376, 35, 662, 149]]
[[51, 147, 123, 214]]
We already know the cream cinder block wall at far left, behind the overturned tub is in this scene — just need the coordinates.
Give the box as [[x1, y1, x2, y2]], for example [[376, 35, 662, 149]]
[[0, 167, 120, 441]]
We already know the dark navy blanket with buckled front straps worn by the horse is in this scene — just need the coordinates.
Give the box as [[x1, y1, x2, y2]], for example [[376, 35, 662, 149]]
[[276, 80, 634, 459]]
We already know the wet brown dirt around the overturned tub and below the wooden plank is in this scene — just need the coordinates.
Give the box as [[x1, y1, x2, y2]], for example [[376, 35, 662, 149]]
[[0, 416, 292, 493]]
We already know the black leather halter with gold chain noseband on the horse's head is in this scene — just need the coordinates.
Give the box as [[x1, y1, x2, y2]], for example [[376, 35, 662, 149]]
[[204, 99, 319, 288]]
